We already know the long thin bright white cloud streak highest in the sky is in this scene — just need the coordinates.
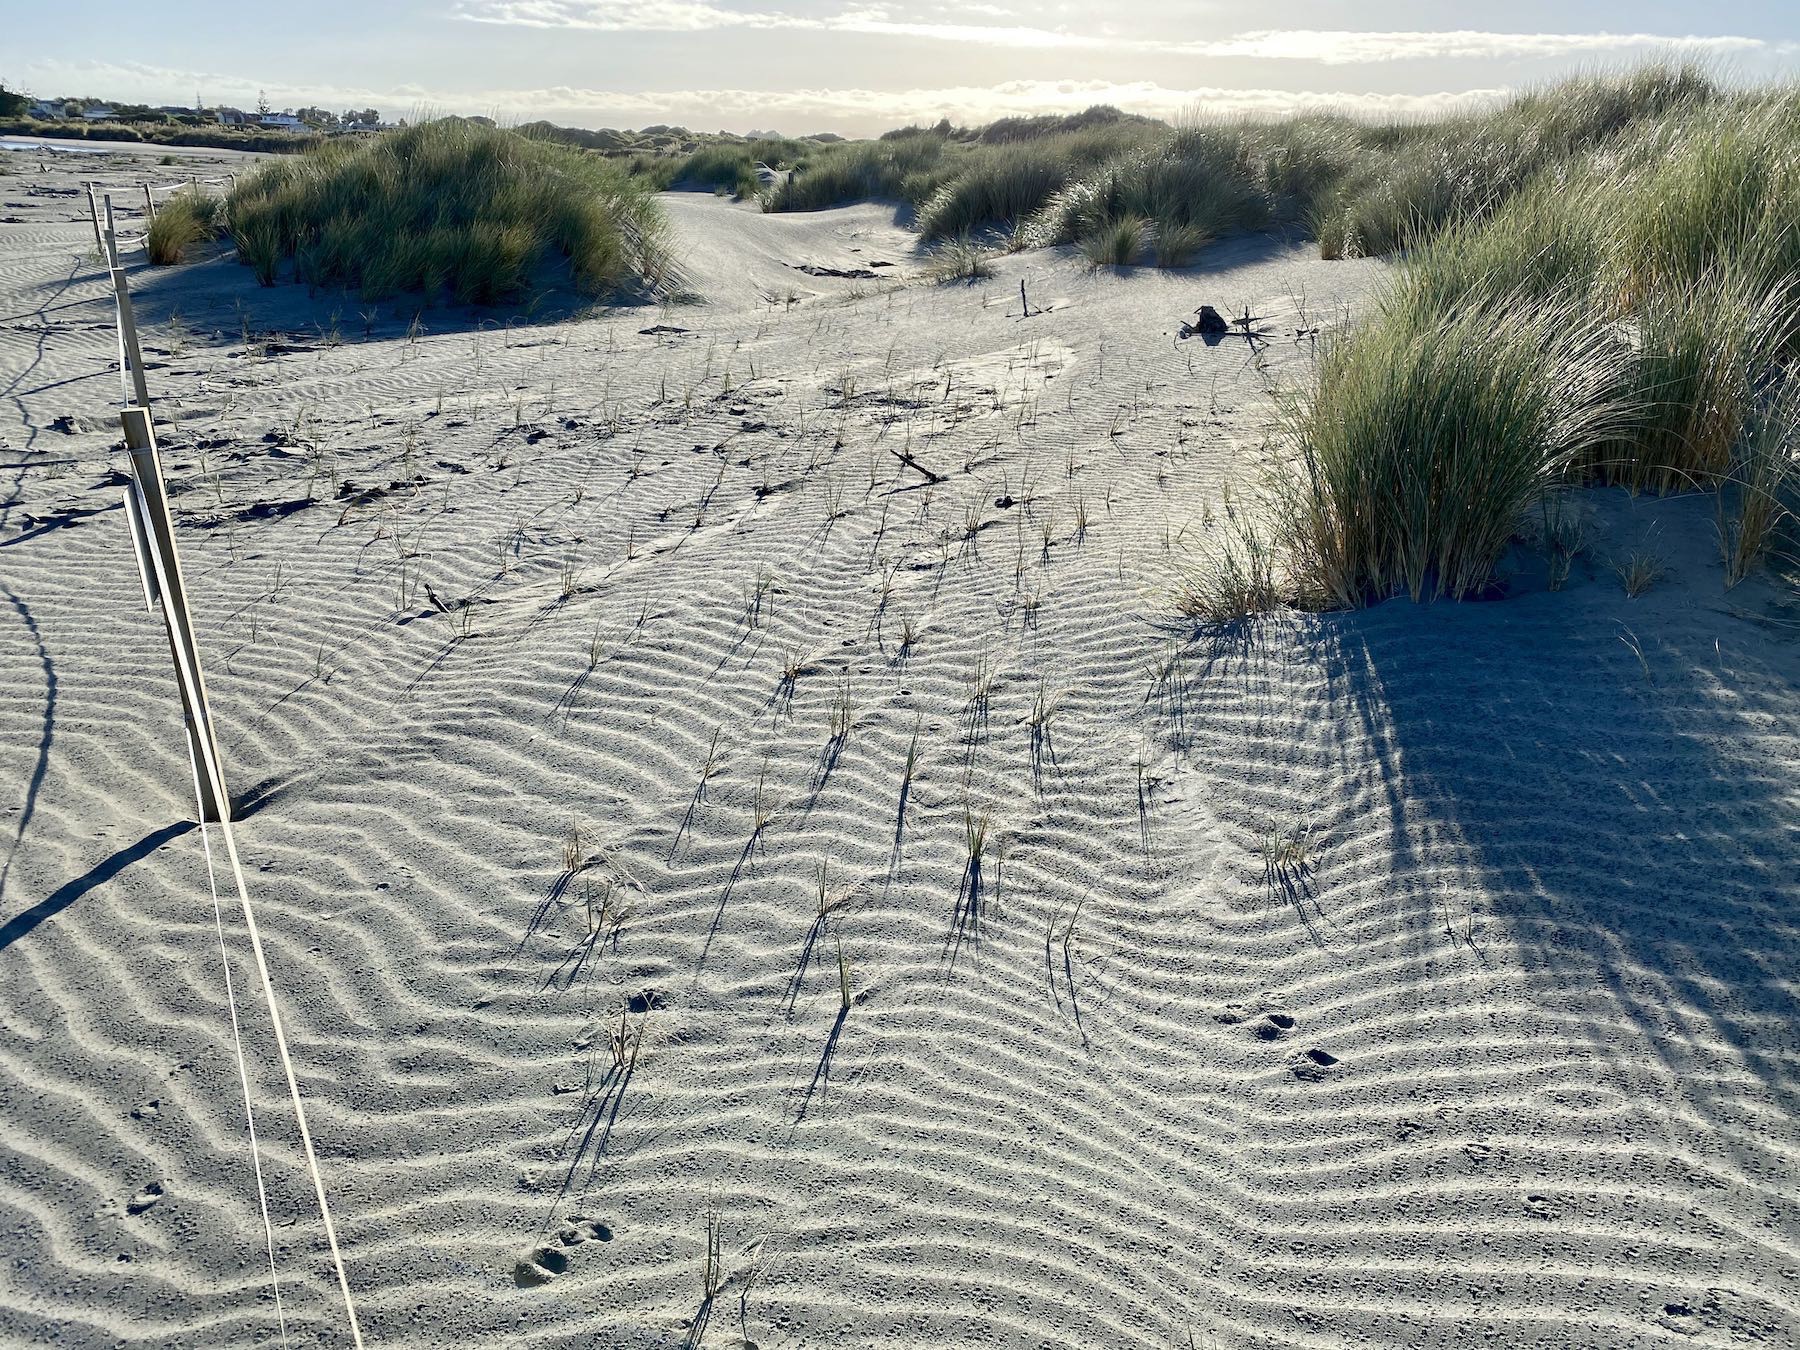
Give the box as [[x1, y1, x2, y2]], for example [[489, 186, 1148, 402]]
[[455, 0, 1787, 65]]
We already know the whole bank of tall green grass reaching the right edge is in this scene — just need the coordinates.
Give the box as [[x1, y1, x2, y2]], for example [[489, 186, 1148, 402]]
[[1273, 88, 1800, 607]]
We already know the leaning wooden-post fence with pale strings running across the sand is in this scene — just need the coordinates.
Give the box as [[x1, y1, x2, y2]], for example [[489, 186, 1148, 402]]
[[99, 192, 362, 1350]]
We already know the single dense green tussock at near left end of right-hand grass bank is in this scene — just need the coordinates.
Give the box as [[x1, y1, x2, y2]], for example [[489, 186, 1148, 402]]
[[1276, 295, 1627, 607]]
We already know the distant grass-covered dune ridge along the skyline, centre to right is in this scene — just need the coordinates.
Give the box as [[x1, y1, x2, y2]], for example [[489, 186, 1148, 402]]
[[763, 65, 1721, 270]]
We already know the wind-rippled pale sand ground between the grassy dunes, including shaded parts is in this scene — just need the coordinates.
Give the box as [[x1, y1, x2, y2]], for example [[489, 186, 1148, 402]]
[[0, 155, 1800, 1350]]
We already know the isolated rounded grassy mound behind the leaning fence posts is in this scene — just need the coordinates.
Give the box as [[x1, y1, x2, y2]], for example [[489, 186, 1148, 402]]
[[227, 119, 671, 304]]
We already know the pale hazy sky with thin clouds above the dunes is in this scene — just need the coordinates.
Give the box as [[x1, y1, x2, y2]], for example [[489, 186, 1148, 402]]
[[14, 0, 1800, 135]]
